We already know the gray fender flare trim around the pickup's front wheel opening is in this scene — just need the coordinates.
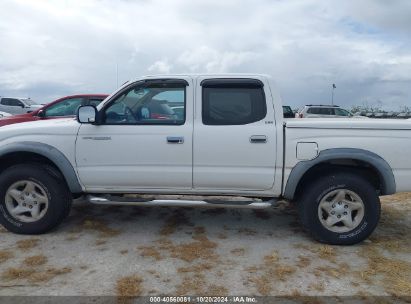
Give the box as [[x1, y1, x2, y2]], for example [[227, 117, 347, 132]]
[[0, 141, 83, 193]]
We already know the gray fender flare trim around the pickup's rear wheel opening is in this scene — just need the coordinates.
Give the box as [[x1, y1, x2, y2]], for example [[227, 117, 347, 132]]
[[283, 148, 396, 199]]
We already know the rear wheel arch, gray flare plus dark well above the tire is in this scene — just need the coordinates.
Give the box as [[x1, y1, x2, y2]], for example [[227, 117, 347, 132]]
[[283, 148, 396, 200]]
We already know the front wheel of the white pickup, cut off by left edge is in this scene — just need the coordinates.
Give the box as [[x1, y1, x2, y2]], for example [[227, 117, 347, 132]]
[[0, 164, 71, 234]]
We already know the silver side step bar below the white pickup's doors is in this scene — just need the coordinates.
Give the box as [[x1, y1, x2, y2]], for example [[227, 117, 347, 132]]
[[86, 194, 278, 209]]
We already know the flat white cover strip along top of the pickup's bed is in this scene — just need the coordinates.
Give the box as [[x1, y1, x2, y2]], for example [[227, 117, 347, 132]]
[[284, 118, 411, 130]]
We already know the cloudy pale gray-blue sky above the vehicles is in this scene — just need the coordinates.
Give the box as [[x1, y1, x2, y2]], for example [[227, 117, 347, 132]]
[[0, 0, 411, 110]]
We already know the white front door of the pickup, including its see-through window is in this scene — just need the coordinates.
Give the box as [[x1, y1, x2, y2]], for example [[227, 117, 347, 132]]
[[76, 77, 193, 192]]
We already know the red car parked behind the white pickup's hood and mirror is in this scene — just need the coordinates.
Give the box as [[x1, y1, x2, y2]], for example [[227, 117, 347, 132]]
[[0, 94, 108, 127]]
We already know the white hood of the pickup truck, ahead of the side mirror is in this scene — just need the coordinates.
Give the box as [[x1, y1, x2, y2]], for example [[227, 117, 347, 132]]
[[0, 118, 80, 141]]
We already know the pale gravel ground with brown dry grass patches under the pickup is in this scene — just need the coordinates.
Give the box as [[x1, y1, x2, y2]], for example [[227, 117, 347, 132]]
[[0, 193, 411, 297]]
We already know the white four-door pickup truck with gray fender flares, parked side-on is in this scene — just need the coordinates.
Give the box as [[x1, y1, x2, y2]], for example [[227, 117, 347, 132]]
[[0, 74, 411, 244]]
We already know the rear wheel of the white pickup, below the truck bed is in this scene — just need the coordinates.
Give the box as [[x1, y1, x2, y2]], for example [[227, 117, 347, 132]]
[[298, 173, 381, 245]]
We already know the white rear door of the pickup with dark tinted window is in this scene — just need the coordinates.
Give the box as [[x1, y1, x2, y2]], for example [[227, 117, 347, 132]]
[[193, 77, 277, 190]]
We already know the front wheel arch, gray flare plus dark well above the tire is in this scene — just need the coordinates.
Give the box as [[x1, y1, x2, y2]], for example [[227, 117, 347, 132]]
[[0, 141, 83, 193]]
